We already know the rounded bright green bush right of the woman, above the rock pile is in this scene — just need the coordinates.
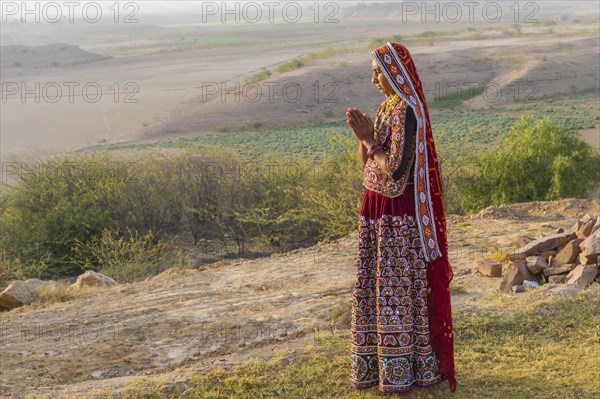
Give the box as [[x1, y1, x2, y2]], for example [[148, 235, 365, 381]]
[[456, 115, 600, 211]]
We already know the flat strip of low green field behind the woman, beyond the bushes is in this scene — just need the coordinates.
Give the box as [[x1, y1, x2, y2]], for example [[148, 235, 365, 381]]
[[101, 94, 600, 160]]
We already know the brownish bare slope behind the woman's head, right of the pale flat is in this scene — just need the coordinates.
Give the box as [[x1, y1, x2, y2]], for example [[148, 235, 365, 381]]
[[91, 34, 600, 147]]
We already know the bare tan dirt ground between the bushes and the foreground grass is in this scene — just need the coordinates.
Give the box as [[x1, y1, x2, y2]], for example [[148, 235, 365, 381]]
[[0, 199, 600, 398]]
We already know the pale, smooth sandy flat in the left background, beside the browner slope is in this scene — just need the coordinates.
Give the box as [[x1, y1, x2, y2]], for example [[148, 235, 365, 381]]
[[0, 44, 310, 159]]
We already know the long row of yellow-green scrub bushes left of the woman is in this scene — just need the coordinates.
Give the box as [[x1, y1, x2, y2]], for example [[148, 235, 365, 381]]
[[0, 136, 362, 281]]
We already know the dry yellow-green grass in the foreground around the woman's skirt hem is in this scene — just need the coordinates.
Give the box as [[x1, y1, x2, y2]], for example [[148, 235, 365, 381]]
[[106, 283, 600, 399]]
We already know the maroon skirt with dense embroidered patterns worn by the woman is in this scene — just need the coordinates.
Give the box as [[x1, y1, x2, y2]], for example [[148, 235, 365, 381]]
[[350, 185, 446, 393]]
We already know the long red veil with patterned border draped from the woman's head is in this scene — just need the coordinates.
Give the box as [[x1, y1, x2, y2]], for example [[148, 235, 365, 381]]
[[371, 42, 456, 392]]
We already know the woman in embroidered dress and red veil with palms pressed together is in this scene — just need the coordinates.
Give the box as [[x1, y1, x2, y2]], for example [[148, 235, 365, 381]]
[[346, 42, 456, 393]]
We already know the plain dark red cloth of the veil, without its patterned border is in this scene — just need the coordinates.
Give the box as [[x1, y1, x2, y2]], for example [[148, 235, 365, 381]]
[[376, 43, 456, 392]]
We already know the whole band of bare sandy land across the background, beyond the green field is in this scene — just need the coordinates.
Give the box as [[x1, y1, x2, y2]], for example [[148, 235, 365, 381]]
[[0, 26, 600, 160]]
